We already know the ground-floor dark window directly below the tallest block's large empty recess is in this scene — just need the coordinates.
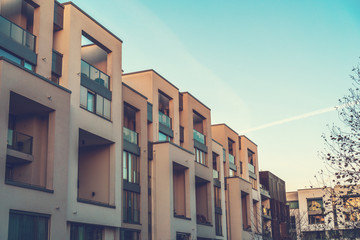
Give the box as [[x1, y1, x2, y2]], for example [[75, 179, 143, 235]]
[[70, 223, 104, 240]]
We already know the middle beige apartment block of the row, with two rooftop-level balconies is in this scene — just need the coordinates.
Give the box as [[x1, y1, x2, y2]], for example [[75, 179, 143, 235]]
[[123, 70, 226, 239]]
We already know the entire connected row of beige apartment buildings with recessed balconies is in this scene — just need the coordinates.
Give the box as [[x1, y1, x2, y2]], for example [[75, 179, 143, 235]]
[[0, 0, 268, 240]]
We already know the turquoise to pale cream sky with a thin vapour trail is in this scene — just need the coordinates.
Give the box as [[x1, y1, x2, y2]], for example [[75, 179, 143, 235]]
[[61, 0, 360, 191]]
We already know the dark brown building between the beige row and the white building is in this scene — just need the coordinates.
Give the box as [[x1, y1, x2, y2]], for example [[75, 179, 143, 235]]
[[259, 171, 289, 240]]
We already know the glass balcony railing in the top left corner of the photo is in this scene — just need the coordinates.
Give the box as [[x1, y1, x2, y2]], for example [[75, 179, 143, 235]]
[[0, 16, 36, 51]]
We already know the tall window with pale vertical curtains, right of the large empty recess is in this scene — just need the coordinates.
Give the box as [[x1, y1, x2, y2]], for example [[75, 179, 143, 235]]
[[123, 151, 140, 184]]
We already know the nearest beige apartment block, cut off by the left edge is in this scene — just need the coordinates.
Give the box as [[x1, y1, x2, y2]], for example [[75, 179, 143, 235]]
[[0, 1, 72, 239]]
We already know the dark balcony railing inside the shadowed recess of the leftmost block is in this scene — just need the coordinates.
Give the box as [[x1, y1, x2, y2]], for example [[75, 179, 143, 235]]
[[7, 129, 33, 154]]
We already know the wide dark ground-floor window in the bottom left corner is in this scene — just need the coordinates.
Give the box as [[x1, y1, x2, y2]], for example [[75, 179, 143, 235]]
[[8, 210, 50, 240]]
